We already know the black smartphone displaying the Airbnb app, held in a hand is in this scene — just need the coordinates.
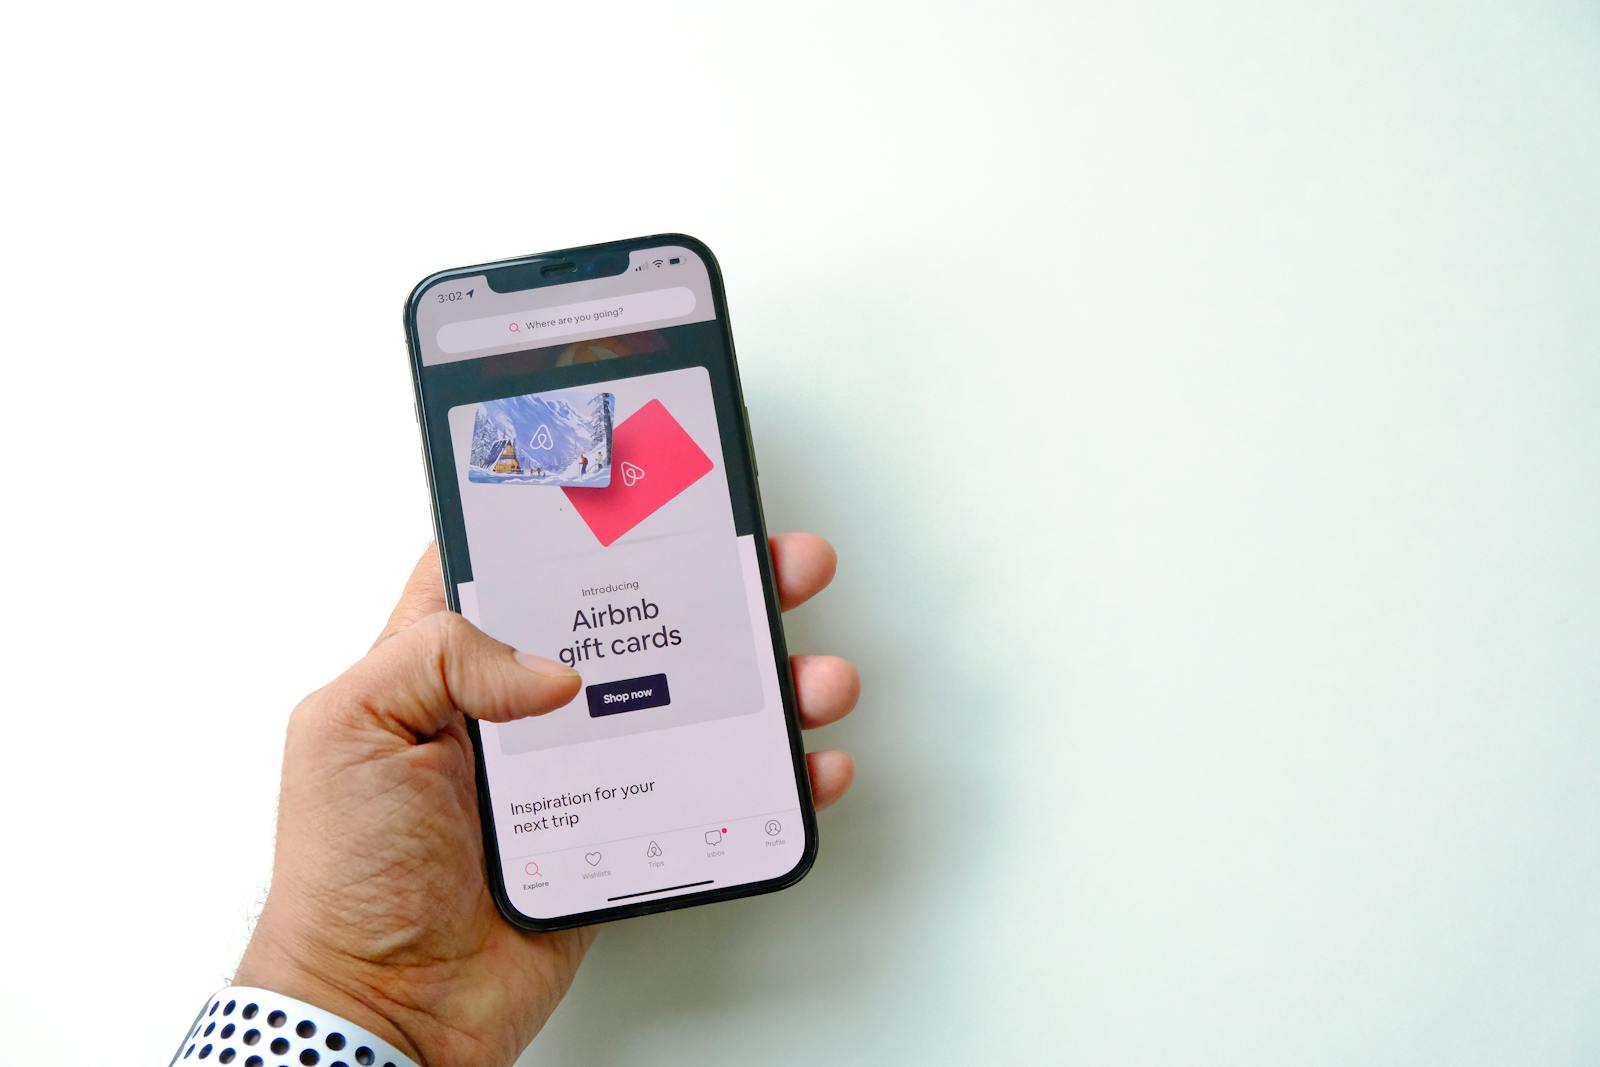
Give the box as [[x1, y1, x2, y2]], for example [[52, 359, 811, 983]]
[[405, 234, 816, 929]]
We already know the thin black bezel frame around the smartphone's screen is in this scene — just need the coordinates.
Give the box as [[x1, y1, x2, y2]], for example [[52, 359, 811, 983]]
[[405, 234, 818, 931]]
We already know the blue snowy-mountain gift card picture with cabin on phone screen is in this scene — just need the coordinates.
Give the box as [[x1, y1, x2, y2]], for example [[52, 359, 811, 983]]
[[467, 389, 616, 490]]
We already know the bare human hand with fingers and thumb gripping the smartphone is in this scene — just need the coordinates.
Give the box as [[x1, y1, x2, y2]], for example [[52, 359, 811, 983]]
[[234, 534, 859, 1067]]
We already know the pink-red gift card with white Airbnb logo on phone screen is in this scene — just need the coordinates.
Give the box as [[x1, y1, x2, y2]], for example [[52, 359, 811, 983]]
[[562, 400, 712, 545]]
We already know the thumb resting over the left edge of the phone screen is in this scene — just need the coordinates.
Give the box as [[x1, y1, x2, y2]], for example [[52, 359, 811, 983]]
[[334, 611, 582, 737]]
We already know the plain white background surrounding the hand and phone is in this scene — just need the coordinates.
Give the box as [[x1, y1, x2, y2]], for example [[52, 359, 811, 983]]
[[0, 0, 1600, 1064]]
